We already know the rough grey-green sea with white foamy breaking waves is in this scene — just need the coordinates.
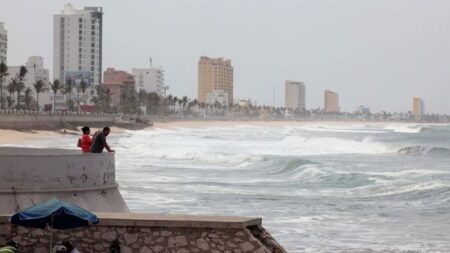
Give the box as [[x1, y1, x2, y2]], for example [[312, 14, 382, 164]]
[[21, 123, 450, 252]]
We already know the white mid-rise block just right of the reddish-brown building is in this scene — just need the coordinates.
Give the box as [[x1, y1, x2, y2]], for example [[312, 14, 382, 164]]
[[131, 67, 168, 96]]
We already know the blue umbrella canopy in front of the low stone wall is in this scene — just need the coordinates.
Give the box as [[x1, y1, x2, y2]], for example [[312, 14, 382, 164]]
[[11, 198, 98, 229]]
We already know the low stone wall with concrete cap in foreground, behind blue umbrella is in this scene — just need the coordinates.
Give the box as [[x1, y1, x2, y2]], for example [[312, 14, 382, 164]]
[[0, 213, 286, 253]]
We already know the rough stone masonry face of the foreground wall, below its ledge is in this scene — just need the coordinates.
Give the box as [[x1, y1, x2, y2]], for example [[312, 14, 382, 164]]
[[0, 223, 285, 253]]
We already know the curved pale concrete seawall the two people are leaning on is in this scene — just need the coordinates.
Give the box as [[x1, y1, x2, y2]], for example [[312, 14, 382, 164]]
[[0, 147, 128, 213]]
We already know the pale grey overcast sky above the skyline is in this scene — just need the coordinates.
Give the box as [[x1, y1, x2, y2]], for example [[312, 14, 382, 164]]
[[0, 0, 450, 114]]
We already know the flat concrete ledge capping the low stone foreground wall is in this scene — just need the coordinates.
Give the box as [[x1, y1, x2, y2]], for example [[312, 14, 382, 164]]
[[0, 213, 262, 229]]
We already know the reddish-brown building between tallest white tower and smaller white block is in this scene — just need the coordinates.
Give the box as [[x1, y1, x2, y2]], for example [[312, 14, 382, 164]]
[[103, 68, 135, 106]]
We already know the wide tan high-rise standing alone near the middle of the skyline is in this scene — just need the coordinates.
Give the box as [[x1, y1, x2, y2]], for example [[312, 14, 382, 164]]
[[197, 56, 233, 104]]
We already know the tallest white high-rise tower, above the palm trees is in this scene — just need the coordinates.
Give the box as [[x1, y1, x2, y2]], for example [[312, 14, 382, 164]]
[[53, 4, 103, 95]]
